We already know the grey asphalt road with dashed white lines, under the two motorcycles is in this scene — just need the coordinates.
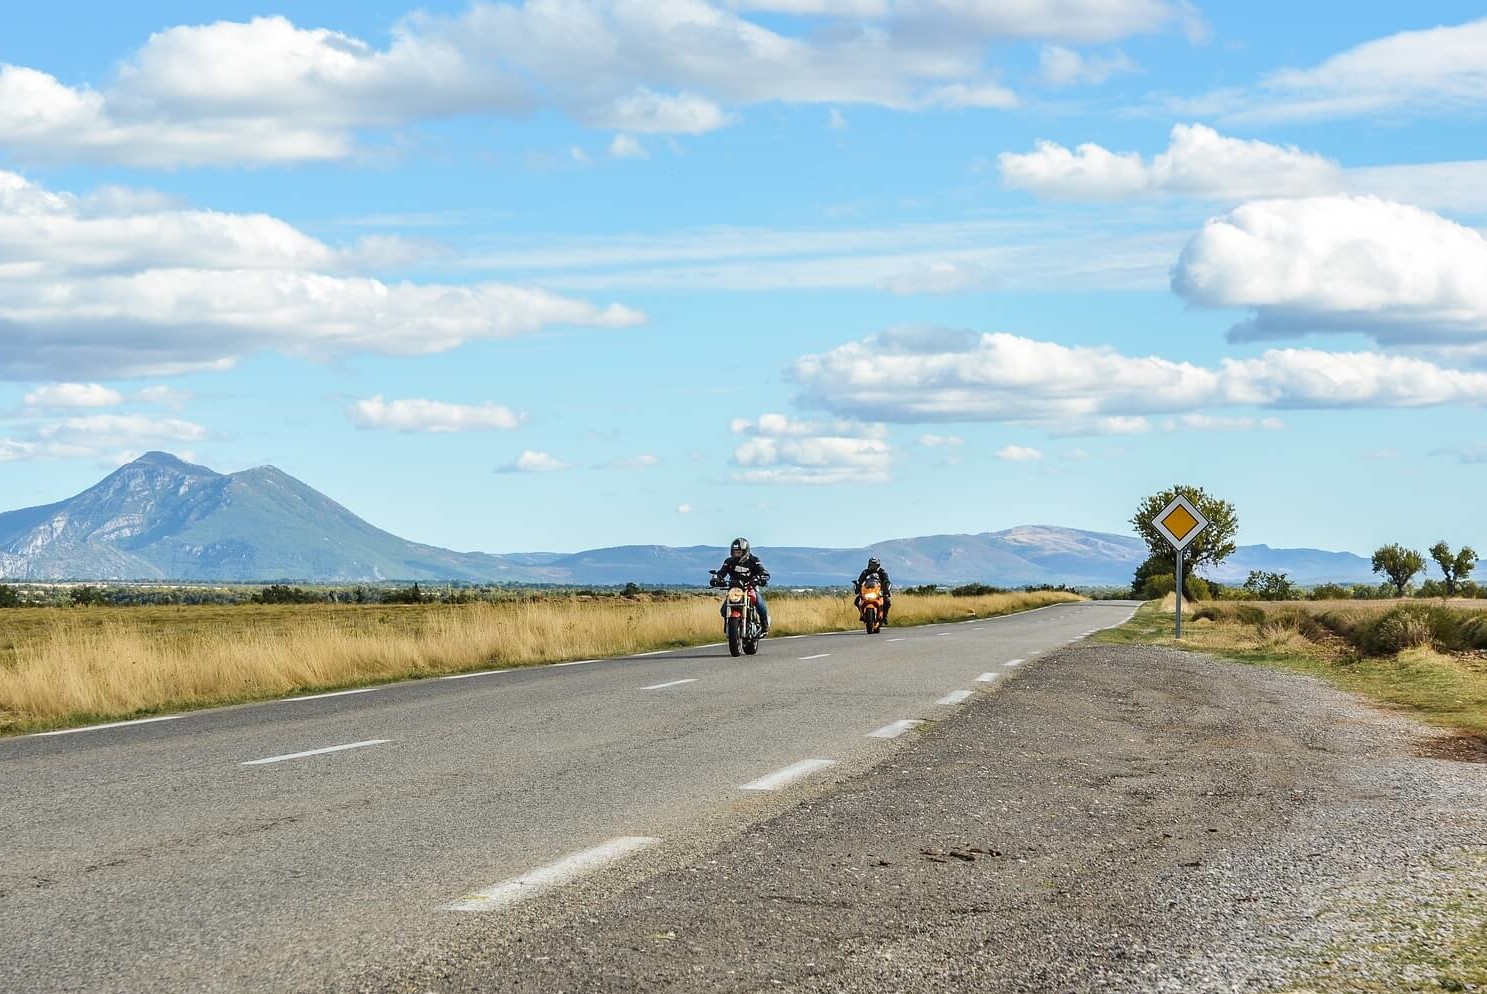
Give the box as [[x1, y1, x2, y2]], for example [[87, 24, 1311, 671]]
[[0, 603, 1135, 993]]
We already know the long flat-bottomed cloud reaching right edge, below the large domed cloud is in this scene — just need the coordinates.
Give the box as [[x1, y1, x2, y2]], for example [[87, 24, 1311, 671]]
[[790, 329, 1487, 435]]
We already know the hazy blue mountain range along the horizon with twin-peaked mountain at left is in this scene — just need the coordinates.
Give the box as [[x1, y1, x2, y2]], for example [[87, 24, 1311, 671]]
[[0, 452, 1374, 586]]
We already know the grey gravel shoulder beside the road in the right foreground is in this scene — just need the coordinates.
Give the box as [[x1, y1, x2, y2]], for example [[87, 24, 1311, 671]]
[[346, 644, 1487, 994]]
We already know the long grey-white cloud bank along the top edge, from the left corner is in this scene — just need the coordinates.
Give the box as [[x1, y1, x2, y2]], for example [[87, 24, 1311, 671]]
[[0, 0, 1185, 165]]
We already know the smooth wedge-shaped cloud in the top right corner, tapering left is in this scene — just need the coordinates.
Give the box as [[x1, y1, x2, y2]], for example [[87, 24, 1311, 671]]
[[1175, 19, 1487, 121]]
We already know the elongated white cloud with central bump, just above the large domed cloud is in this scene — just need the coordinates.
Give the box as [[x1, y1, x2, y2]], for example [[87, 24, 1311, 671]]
[[998, 124, 1343, 201]]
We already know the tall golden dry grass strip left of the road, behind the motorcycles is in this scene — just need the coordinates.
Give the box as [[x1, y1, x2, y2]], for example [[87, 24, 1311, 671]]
[[0, 592, 1078, 734]]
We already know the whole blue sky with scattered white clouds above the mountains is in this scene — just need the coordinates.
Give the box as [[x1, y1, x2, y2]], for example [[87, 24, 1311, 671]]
[[0, 0, 1487, 554]]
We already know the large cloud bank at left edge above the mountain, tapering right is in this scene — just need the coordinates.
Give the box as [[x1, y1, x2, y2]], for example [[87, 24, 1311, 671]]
[[0, 171, 644, 379]]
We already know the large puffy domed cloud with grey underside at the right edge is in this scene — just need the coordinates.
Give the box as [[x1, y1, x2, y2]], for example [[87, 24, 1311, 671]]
[[1172, 196, 1487, 347]]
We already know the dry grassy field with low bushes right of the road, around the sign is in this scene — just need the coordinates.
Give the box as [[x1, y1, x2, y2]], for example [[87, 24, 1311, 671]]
[[1102, 595, 1487, 741]]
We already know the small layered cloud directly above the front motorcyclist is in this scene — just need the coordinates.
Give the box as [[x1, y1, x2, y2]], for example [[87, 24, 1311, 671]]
[[732, 414, 892, 484]]
